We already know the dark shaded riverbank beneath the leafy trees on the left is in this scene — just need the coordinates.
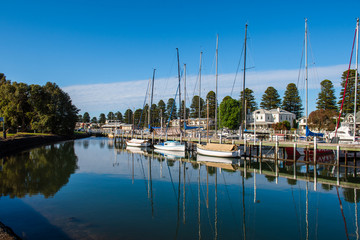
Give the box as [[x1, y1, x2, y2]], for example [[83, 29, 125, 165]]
[[0, 133, 90, 157]]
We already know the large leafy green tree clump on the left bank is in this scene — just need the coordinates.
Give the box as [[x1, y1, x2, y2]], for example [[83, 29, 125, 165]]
[[0, 74, 79, 135]]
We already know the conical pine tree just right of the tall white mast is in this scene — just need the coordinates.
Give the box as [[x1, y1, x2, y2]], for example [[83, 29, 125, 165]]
[[316, 79, 337, 110]]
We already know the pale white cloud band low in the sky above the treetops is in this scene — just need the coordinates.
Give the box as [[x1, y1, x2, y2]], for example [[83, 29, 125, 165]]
[[63, 65, 347, 116]]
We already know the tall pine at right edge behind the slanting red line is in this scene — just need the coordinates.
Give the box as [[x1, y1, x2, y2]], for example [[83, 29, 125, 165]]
[[338, 69, 360, 114]]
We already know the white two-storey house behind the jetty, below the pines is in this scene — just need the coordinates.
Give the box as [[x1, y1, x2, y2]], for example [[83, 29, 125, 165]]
[[246, 108, 296, 130]]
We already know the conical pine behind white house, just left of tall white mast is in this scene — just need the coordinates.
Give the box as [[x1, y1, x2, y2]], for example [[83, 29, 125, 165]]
[[282, 83, 303, 118]]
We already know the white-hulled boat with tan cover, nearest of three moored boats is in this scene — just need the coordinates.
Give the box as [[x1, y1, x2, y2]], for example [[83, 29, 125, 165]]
[[197, 143, 240, 158]]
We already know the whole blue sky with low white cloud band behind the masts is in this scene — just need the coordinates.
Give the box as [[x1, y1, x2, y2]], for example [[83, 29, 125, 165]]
[[0, 0, 360, 116]]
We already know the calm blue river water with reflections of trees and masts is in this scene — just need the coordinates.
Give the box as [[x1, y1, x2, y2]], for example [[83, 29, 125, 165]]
[[0, 138, 360, 239]]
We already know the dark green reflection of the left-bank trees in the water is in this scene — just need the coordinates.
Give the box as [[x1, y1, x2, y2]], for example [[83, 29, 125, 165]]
[[0, 142, 77, 198]]
